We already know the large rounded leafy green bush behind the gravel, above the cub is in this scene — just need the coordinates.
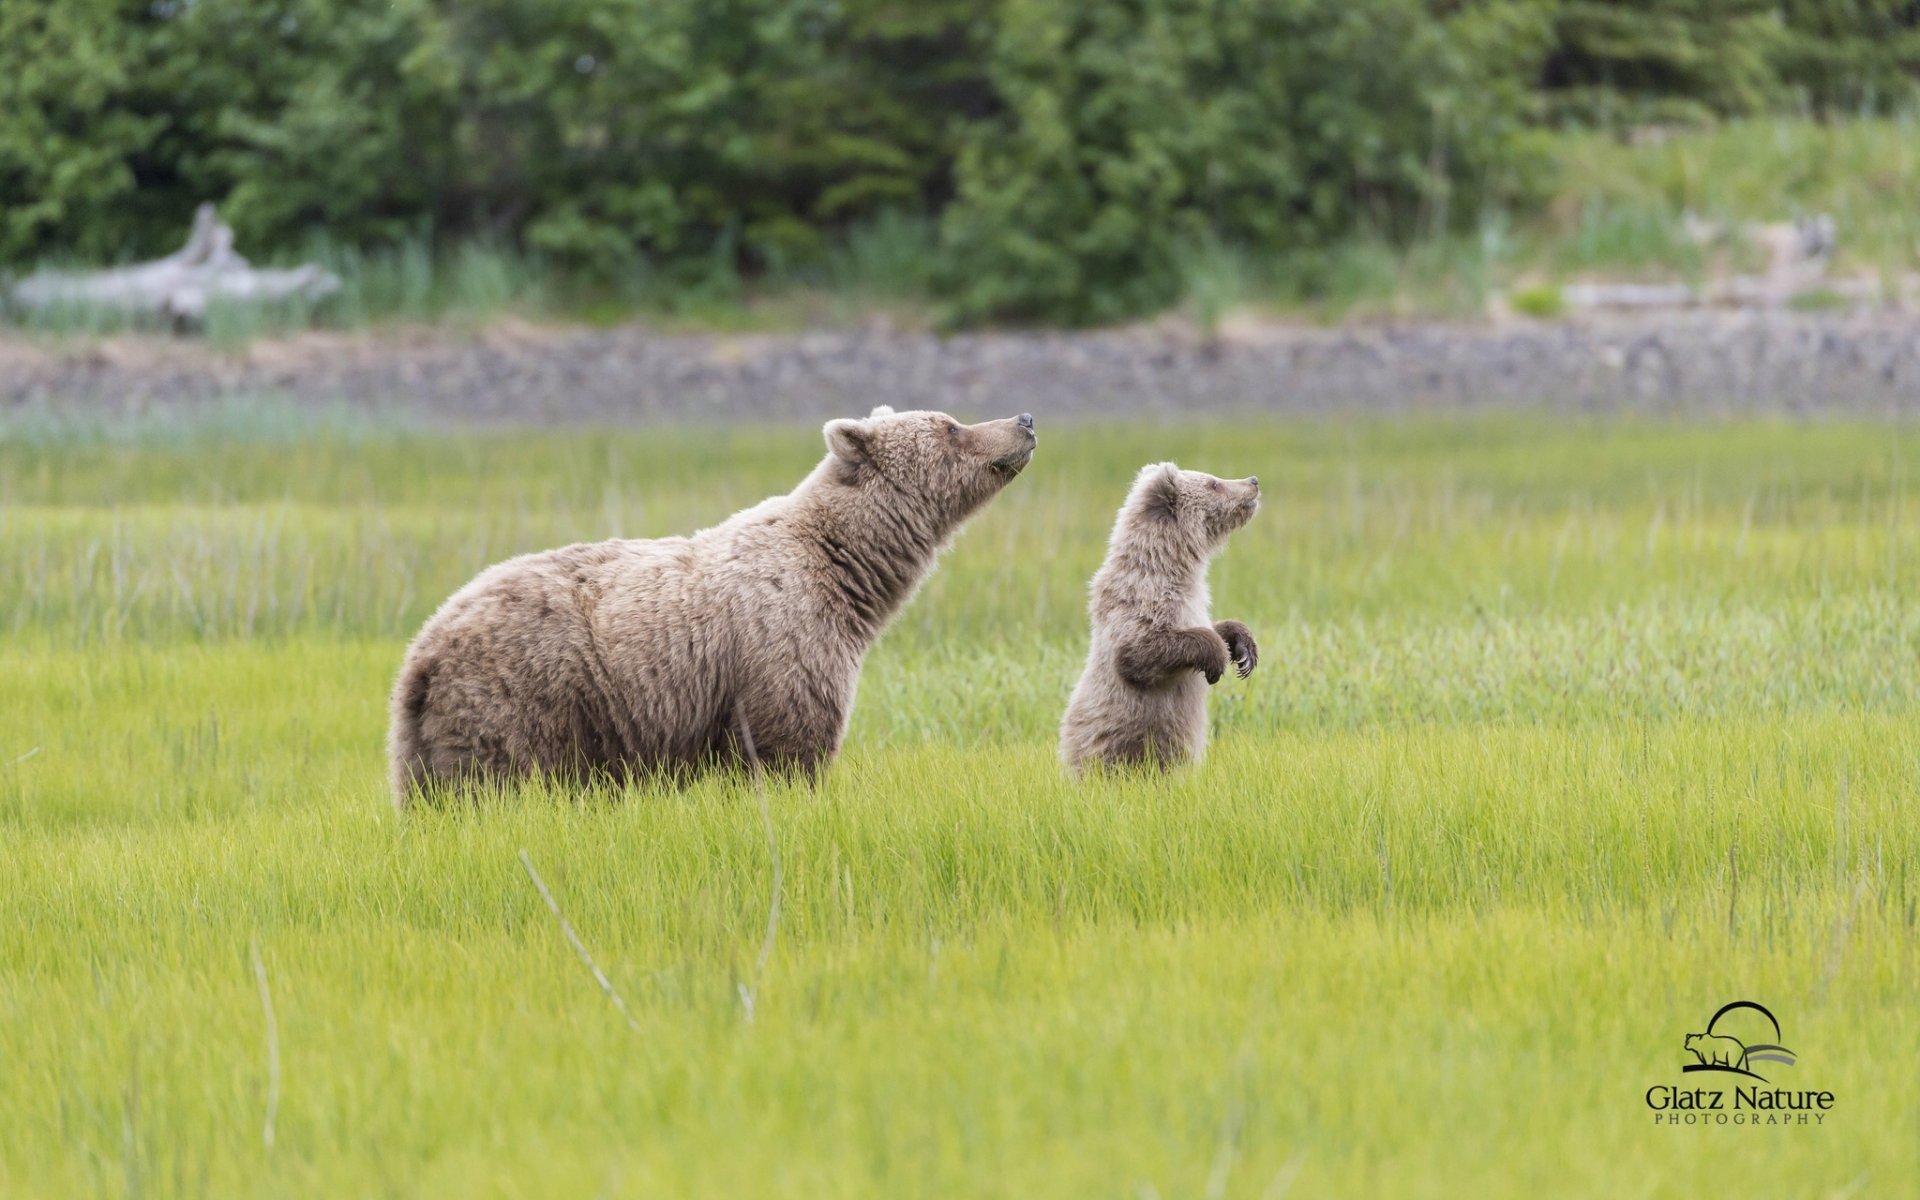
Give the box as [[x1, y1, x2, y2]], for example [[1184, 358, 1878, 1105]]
[[943, 0, 1551, 323]]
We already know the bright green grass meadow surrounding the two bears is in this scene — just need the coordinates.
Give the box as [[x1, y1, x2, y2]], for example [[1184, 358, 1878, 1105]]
[[0, 413, 1920, 1198]]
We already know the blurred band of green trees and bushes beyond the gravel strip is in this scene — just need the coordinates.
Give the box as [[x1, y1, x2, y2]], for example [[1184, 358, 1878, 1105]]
[[0, 0, 1920, 324]]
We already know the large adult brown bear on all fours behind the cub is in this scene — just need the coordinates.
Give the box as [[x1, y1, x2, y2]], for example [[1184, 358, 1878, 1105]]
[[388, 407, 1035, 804]]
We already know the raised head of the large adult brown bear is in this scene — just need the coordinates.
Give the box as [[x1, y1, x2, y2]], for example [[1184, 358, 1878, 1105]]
[[824, 405, 1039, 522]]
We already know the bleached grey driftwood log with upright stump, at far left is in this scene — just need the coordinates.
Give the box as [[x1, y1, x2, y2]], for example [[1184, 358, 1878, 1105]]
[[13, 204, 340, 323]]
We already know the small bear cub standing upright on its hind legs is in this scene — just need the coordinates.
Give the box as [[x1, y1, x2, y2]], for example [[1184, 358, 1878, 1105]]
[[1060, 463, 1260, 772]]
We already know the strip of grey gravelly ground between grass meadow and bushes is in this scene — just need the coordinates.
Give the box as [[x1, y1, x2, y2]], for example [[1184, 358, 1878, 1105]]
[[0, 313, 1920, 424]]
